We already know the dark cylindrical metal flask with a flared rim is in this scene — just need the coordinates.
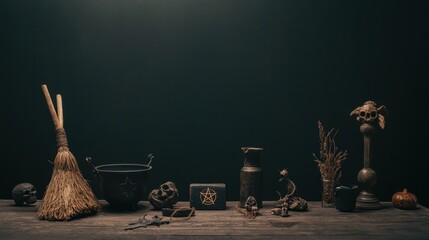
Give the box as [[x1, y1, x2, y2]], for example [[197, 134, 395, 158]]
[[240, 147, 264, 208]]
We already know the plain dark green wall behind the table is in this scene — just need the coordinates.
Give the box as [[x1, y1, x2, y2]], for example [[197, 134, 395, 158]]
[[0, 0, 429, 206]]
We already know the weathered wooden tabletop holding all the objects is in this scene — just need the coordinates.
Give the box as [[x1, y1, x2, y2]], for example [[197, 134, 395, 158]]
[[0, 200, 429, 240]]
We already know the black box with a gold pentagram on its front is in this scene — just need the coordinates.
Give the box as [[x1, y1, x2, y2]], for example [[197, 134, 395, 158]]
[[189, 183, 226, 210]]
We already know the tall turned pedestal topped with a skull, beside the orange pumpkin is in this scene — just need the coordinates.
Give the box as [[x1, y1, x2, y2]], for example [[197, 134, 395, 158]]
[[350, 101, 388, 210]]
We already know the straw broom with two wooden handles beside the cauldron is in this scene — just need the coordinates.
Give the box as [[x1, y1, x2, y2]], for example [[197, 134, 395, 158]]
[[38, 84, 101, 221]]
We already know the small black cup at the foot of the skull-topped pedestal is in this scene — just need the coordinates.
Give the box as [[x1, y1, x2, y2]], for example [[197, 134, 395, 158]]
[[335, 185, 360, 212]]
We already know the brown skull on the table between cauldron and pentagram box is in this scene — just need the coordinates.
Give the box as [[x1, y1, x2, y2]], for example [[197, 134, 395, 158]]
[[149, 181, 179, 210]]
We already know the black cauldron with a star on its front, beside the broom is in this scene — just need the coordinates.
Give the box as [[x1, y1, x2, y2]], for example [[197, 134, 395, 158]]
[[86, 155, 153, 210]]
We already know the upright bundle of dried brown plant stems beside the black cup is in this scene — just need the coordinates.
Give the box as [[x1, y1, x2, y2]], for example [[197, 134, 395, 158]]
[[313, 121, 348, 202]]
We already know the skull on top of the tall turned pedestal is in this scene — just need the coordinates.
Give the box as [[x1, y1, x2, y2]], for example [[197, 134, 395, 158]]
[[350, 101, 387, 129]]
